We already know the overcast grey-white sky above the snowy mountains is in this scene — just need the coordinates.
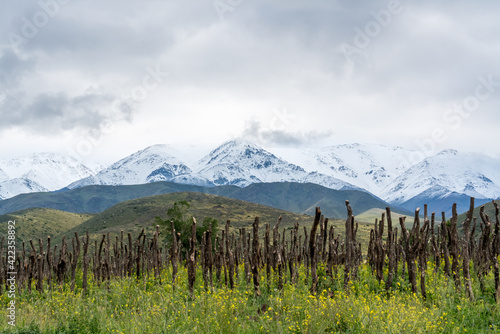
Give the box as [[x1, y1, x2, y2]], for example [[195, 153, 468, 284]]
[[0, 0, 500, 163]]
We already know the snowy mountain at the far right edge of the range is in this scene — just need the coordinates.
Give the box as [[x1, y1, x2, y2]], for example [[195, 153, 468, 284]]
[[381, 150, 500, 204]]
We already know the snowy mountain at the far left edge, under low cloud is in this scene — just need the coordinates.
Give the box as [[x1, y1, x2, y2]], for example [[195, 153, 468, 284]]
[[0, 153, 98, 199]]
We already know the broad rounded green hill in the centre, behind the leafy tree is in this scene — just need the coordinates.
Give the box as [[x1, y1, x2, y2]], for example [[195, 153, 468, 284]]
[[56, 192, 373, 249]]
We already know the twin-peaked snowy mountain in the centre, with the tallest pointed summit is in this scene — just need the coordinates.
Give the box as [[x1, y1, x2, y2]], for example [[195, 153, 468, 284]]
[[68, 139, 356, 189]]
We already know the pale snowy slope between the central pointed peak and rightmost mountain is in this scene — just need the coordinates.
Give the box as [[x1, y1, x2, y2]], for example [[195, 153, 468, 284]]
[[276, 144, 422, 196]]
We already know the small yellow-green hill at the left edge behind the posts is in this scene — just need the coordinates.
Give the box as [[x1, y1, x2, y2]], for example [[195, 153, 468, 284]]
[[0, 208, 92, 242]]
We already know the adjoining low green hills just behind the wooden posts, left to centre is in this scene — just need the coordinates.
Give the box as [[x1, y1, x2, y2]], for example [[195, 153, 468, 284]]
[[0, 192, 373, 249]]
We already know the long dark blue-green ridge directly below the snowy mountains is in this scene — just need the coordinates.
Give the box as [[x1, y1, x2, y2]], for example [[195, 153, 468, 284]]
[[0, 182, 396, 218]]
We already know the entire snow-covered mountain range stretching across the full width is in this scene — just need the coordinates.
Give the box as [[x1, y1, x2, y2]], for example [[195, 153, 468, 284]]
[[0, 139, 500, 214]]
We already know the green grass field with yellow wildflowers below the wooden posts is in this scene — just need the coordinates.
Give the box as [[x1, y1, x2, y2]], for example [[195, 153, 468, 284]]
[[0, 265, 500, 334]]
